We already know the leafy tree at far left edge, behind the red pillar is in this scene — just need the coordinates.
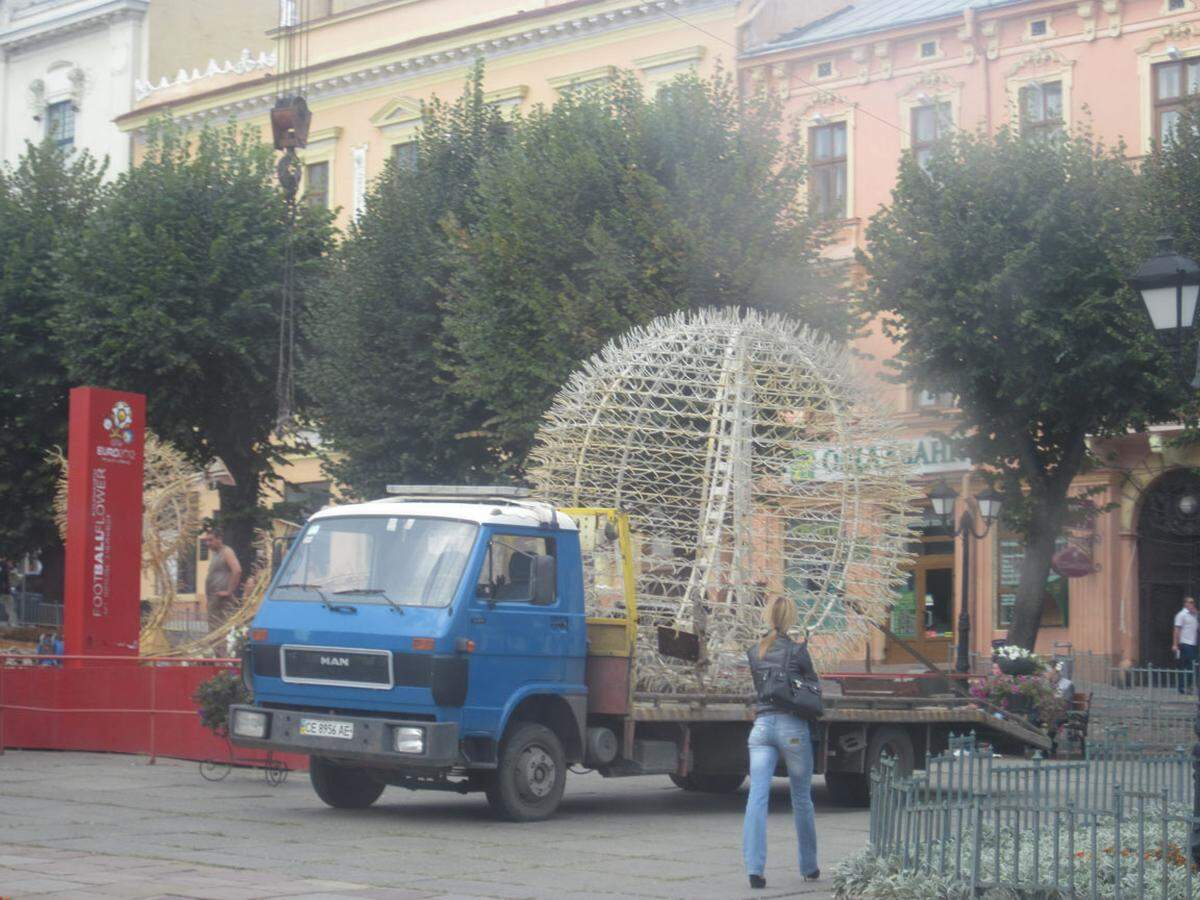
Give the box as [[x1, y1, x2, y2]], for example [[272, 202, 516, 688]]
[[0, 143, 103, 559]]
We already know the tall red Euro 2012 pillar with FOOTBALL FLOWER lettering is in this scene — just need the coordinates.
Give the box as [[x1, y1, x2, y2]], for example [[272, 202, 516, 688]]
[[62, 388, 145, 656]]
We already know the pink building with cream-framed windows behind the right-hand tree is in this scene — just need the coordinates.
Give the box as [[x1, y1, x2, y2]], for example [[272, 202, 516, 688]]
[[739, 0, 1200, 665]]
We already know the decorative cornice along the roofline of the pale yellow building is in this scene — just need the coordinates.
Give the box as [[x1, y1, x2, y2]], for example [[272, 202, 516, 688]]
[[116, 0, 736, 130]]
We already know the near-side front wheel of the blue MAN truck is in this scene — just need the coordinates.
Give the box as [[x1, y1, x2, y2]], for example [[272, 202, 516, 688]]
[[486, 722, 566, 822]]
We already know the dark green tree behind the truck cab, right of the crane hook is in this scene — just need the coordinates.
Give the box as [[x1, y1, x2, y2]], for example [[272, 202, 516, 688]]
[[302, 67, 508, 496]]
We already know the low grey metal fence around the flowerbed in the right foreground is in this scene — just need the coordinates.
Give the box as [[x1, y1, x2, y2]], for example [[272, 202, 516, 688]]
[[870, 737, 1200, 900]]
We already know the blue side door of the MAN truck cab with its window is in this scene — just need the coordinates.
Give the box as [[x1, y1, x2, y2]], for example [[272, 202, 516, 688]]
[[464, 532, 578, 731]]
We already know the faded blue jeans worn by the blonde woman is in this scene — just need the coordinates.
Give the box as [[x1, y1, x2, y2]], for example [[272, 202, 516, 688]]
[[742, 713, 817, 875]]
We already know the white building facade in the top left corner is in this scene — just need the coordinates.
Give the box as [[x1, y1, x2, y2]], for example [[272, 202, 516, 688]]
[[0, 0, 150, 174]]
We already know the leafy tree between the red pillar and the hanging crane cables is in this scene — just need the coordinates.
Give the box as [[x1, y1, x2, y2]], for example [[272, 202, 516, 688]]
[[56, 121, 330, 571]]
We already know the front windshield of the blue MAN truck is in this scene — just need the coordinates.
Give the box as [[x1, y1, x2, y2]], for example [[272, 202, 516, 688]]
[[271, 516, 478, 606]]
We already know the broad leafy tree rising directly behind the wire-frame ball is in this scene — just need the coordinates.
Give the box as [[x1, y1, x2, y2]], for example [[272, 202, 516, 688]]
[[444, 71, 851, 466]]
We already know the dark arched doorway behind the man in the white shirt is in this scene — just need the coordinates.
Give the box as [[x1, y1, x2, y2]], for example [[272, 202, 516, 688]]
[[1138, 469, 1200, 666]]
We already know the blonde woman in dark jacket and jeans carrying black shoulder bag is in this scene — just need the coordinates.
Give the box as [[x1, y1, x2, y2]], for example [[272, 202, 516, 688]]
[[742, 595, 821, 888]]
